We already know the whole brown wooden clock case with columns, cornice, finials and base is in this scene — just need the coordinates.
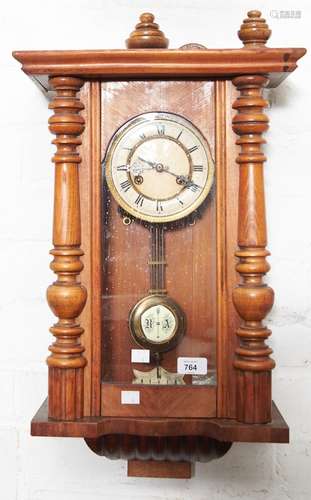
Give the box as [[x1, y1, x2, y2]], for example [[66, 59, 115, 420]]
[[14, 11, 305, 477]]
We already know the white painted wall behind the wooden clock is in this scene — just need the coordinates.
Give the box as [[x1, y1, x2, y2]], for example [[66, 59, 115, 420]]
[[0, 0, 311, 500]]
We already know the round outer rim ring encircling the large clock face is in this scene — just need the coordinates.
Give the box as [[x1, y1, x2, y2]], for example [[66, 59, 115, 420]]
[[104, 111, 215, 224]]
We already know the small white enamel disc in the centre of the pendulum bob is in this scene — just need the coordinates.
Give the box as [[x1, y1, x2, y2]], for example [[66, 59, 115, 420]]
[[141, 304, 176, 343]]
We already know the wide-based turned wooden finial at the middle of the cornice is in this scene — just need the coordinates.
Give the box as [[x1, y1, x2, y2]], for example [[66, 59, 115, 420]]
[[126, 12, 168, 49]]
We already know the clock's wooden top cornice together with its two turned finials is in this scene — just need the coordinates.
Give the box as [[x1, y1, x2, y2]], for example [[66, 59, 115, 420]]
[[13, 10, 306, 91]]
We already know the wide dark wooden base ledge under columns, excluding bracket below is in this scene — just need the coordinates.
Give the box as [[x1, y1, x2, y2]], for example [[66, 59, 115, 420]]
[[31, 399, 289, 443]]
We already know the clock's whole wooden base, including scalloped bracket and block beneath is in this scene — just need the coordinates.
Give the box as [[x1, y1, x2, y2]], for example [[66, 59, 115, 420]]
[[31, 399, 289, 478]]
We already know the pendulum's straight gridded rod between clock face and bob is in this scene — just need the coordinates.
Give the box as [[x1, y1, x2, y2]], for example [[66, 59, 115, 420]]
[[149, 224, 167, 295]]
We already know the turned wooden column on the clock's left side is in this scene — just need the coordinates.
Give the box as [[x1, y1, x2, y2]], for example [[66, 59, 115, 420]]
[[47, 76, 87, 420]]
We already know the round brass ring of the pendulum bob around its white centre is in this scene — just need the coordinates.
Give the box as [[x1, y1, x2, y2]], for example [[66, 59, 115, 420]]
[[129, 294, 186, 353]]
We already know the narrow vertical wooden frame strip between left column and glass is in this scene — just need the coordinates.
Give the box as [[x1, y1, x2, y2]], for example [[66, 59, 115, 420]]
[[80, 81, 102, 417]]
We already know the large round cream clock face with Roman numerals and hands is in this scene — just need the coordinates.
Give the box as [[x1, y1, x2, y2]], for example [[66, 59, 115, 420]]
[[105, 113, 214, 222]]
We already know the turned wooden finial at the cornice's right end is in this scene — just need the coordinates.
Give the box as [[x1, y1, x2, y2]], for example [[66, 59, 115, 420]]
[[238, 10, 271, 48]]
